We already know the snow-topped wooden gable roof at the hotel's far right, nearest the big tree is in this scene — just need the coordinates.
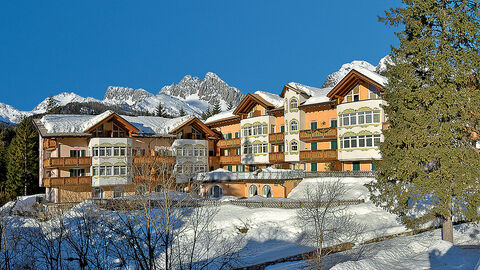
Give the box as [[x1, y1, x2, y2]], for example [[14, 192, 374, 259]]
[[327, 68, 388, 99]]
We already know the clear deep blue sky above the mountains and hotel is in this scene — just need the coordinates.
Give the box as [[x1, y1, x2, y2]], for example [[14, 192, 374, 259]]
[[0, 0, 400, 110]]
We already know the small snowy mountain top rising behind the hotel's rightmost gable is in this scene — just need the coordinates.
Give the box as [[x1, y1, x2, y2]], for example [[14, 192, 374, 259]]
[[322, 55, 392, 88]]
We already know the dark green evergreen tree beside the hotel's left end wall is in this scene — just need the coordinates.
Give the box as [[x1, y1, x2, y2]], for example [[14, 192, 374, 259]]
[[5, 118, 38, 199]]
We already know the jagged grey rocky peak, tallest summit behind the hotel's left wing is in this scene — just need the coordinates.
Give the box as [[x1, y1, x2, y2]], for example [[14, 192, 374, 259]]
[[159, 72, 245, 111]]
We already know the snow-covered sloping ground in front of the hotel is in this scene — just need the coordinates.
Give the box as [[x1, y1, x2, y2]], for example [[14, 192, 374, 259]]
[[0, 178, 480, 269]]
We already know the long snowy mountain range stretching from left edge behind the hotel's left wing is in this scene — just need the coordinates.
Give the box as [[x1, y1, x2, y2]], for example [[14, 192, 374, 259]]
[[0, 72, 245, 123]]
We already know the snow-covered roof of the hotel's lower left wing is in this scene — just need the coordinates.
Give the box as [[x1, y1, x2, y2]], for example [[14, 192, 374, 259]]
[[40, 111, 190, 134]]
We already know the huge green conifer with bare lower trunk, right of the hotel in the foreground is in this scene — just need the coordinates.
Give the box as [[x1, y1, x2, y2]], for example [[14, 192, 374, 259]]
[[368, 0, 480, 242]]
